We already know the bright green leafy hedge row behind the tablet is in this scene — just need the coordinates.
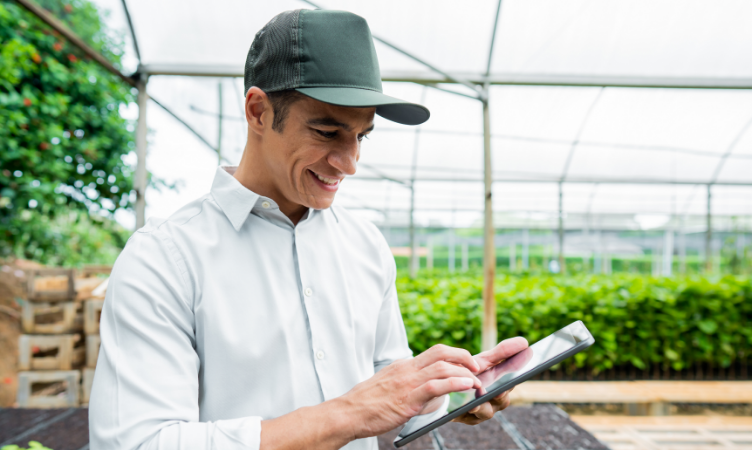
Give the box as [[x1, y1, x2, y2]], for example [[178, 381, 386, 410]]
[[397, 272, 752, 374]]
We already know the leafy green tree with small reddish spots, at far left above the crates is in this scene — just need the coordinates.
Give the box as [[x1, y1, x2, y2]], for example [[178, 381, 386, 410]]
[[0, 0, 135, 264]]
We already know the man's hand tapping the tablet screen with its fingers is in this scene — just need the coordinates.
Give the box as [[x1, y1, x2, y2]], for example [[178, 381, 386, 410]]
[[338, 345, 488, 439]]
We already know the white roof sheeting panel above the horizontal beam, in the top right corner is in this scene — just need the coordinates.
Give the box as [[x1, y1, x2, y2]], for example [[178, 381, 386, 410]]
[[492, 0, 752, 77]]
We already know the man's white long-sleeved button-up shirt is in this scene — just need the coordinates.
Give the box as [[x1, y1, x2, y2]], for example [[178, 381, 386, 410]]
[[89, 167, 444, 450]]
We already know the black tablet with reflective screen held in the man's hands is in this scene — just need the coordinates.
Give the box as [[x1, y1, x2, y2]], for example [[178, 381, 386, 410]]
[[399, 322, 589, 438]]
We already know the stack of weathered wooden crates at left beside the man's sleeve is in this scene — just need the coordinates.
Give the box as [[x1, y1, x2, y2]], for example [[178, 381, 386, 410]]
[[17, 267, 107, 408]]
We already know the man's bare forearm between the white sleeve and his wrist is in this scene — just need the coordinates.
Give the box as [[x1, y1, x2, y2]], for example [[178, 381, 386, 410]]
[[261, 398, 356, 450]]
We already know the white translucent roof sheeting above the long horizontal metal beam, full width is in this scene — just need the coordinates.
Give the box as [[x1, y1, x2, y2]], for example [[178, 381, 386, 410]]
[[109, 0, 752, 77]]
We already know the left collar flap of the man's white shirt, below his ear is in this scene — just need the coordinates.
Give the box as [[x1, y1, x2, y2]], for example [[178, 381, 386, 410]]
[[211, 166, 259, 231]]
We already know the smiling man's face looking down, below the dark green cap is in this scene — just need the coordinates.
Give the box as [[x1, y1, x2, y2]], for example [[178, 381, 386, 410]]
[[263, 97, 376, 209]]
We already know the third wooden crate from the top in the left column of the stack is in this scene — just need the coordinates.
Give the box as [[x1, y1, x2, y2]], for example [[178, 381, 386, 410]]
[[18, 334, 86, 370]]
